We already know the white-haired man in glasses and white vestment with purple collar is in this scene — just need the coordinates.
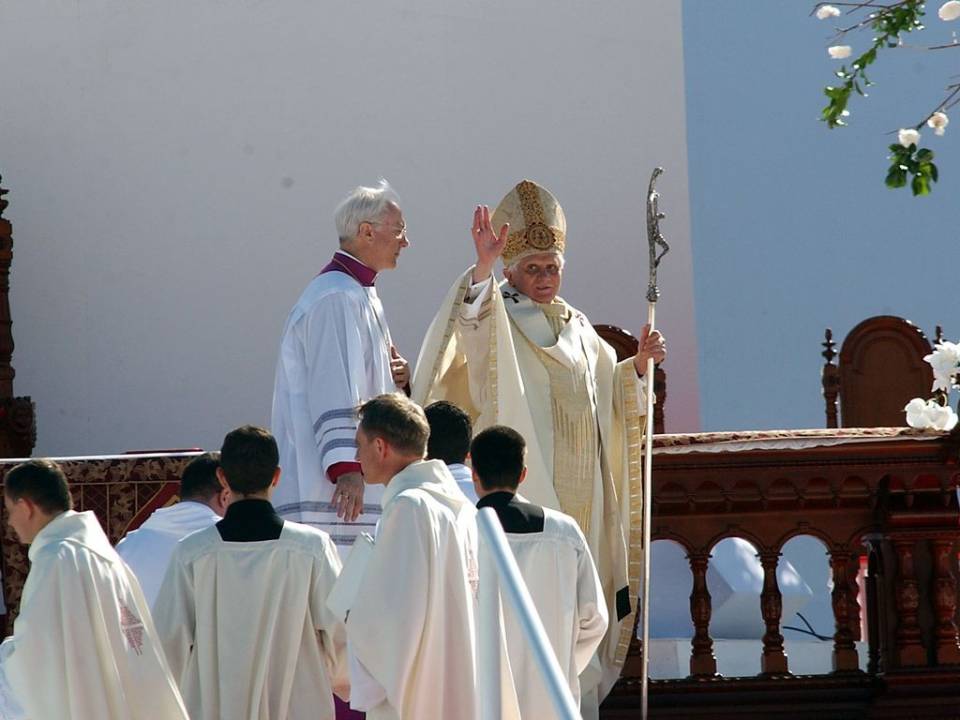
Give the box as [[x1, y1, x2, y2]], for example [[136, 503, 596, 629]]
[[271, 180, 410, 549]]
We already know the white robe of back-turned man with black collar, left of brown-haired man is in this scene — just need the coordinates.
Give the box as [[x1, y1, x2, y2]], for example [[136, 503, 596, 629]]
[[156, 521, 349, 720]]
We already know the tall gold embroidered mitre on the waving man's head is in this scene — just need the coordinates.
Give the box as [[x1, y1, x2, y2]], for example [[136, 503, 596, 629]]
[[490, 180, 567, 265]]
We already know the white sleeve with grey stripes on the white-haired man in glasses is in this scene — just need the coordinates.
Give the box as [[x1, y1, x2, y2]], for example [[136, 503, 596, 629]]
[[298, 293, 369, 473]]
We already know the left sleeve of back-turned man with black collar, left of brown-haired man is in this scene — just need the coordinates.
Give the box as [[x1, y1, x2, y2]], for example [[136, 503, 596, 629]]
[[153, 545, 197, 687]]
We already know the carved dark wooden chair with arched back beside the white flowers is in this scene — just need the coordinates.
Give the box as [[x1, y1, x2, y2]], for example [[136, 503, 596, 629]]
[[822, 315, 943, 428]]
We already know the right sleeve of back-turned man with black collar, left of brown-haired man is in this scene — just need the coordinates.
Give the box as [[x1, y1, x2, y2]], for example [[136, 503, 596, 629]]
[[310, 538, 350, 700]]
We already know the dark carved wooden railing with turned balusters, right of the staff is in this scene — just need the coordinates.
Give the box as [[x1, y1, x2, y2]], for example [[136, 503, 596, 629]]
[[603, 428, 960, 720]]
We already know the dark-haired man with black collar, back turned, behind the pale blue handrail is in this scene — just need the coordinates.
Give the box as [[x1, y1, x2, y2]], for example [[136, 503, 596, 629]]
[[470, 425, 608, 718]]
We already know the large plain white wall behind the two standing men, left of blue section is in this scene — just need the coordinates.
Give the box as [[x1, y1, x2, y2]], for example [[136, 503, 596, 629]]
[[0, 0, 699, 454]]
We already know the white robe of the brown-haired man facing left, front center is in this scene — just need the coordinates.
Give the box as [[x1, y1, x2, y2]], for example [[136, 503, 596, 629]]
[[347, 460, 488, 720]]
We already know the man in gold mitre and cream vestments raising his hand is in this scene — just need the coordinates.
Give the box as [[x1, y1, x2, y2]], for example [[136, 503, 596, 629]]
[[413, 180, 665, 712]]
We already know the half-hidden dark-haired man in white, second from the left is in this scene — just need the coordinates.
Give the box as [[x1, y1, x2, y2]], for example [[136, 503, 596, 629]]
[[117, 453, 229, 609]]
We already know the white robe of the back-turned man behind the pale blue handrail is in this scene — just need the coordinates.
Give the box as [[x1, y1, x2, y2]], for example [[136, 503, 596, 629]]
[[504, 500, 608, 718]]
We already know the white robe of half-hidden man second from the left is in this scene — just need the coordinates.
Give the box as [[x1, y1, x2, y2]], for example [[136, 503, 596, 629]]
[[117, 500, 220, 609]]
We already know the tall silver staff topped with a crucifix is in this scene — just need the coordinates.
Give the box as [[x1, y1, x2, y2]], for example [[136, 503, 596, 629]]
[[640, 168, 670, 720]]
